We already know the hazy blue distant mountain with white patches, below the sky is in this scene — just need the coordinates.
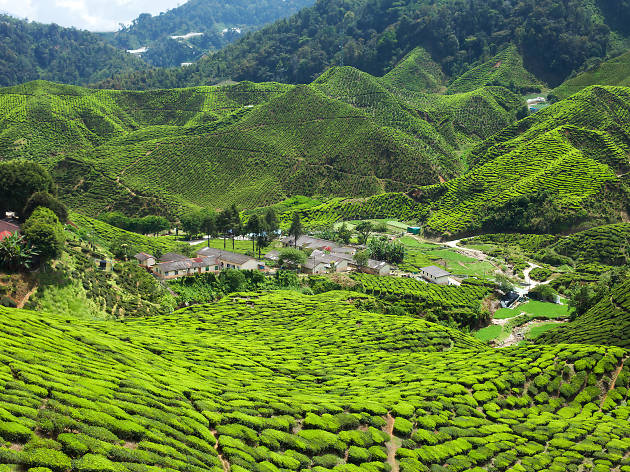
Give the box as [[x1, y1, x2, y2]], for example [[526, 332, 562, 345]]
[[103, 0, 313, 67]]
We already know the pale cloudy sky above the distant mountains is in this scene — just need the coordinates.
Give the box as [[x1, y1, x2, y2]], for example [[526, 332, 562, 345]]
[[0, 0, 186, 31]]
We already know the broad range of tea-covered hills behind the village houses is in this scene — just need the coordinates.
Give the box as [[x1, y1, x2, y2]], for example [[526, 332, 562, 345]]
[[0, 76, 521, 215]]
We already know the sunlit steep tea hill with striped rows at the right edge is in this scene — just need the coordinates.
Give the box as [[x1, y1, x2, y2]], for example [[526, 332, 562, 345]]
[[412, 87, 630, 234]]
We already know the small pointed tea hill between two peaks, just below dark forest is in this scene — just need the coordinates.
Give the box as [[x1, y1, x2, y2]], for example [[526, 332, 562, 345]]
[[447, 45, 544, 93]]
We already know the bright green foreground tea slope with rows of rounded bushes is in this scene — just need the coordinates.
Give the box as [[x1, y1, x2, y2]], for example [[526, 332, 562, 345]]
[[0, 292, 630, 472]]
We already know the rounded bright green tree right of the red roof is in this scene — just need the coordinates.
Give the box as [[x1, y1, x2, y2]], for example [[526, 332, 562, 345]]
[[22, 207, 66, 262]]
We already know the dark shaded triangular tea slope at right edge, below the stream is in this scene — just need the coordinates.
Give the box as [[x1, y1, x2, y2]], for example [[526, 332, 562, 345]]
[[536, 280, 630, 348]]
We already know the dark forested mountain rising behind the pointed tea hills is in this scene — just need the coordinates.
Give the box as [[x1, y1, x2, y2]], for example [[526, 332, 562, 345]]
[[96, 0, 630, 89]]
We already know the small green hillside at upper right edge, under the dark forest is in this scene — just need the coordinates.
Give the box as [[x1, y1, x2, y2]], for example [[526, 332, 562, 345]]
[[552, 52, 630, 100]]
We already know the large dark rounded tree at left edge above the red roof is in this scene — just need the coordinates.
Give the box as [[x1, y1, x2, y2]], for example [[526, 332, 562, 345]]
[[0, 160, 55, 216]]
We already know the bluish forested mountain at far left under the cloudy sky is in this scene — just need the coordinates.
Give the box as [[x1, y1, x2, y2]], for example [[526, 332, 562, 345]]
[[0, 15, 147, 87]]
